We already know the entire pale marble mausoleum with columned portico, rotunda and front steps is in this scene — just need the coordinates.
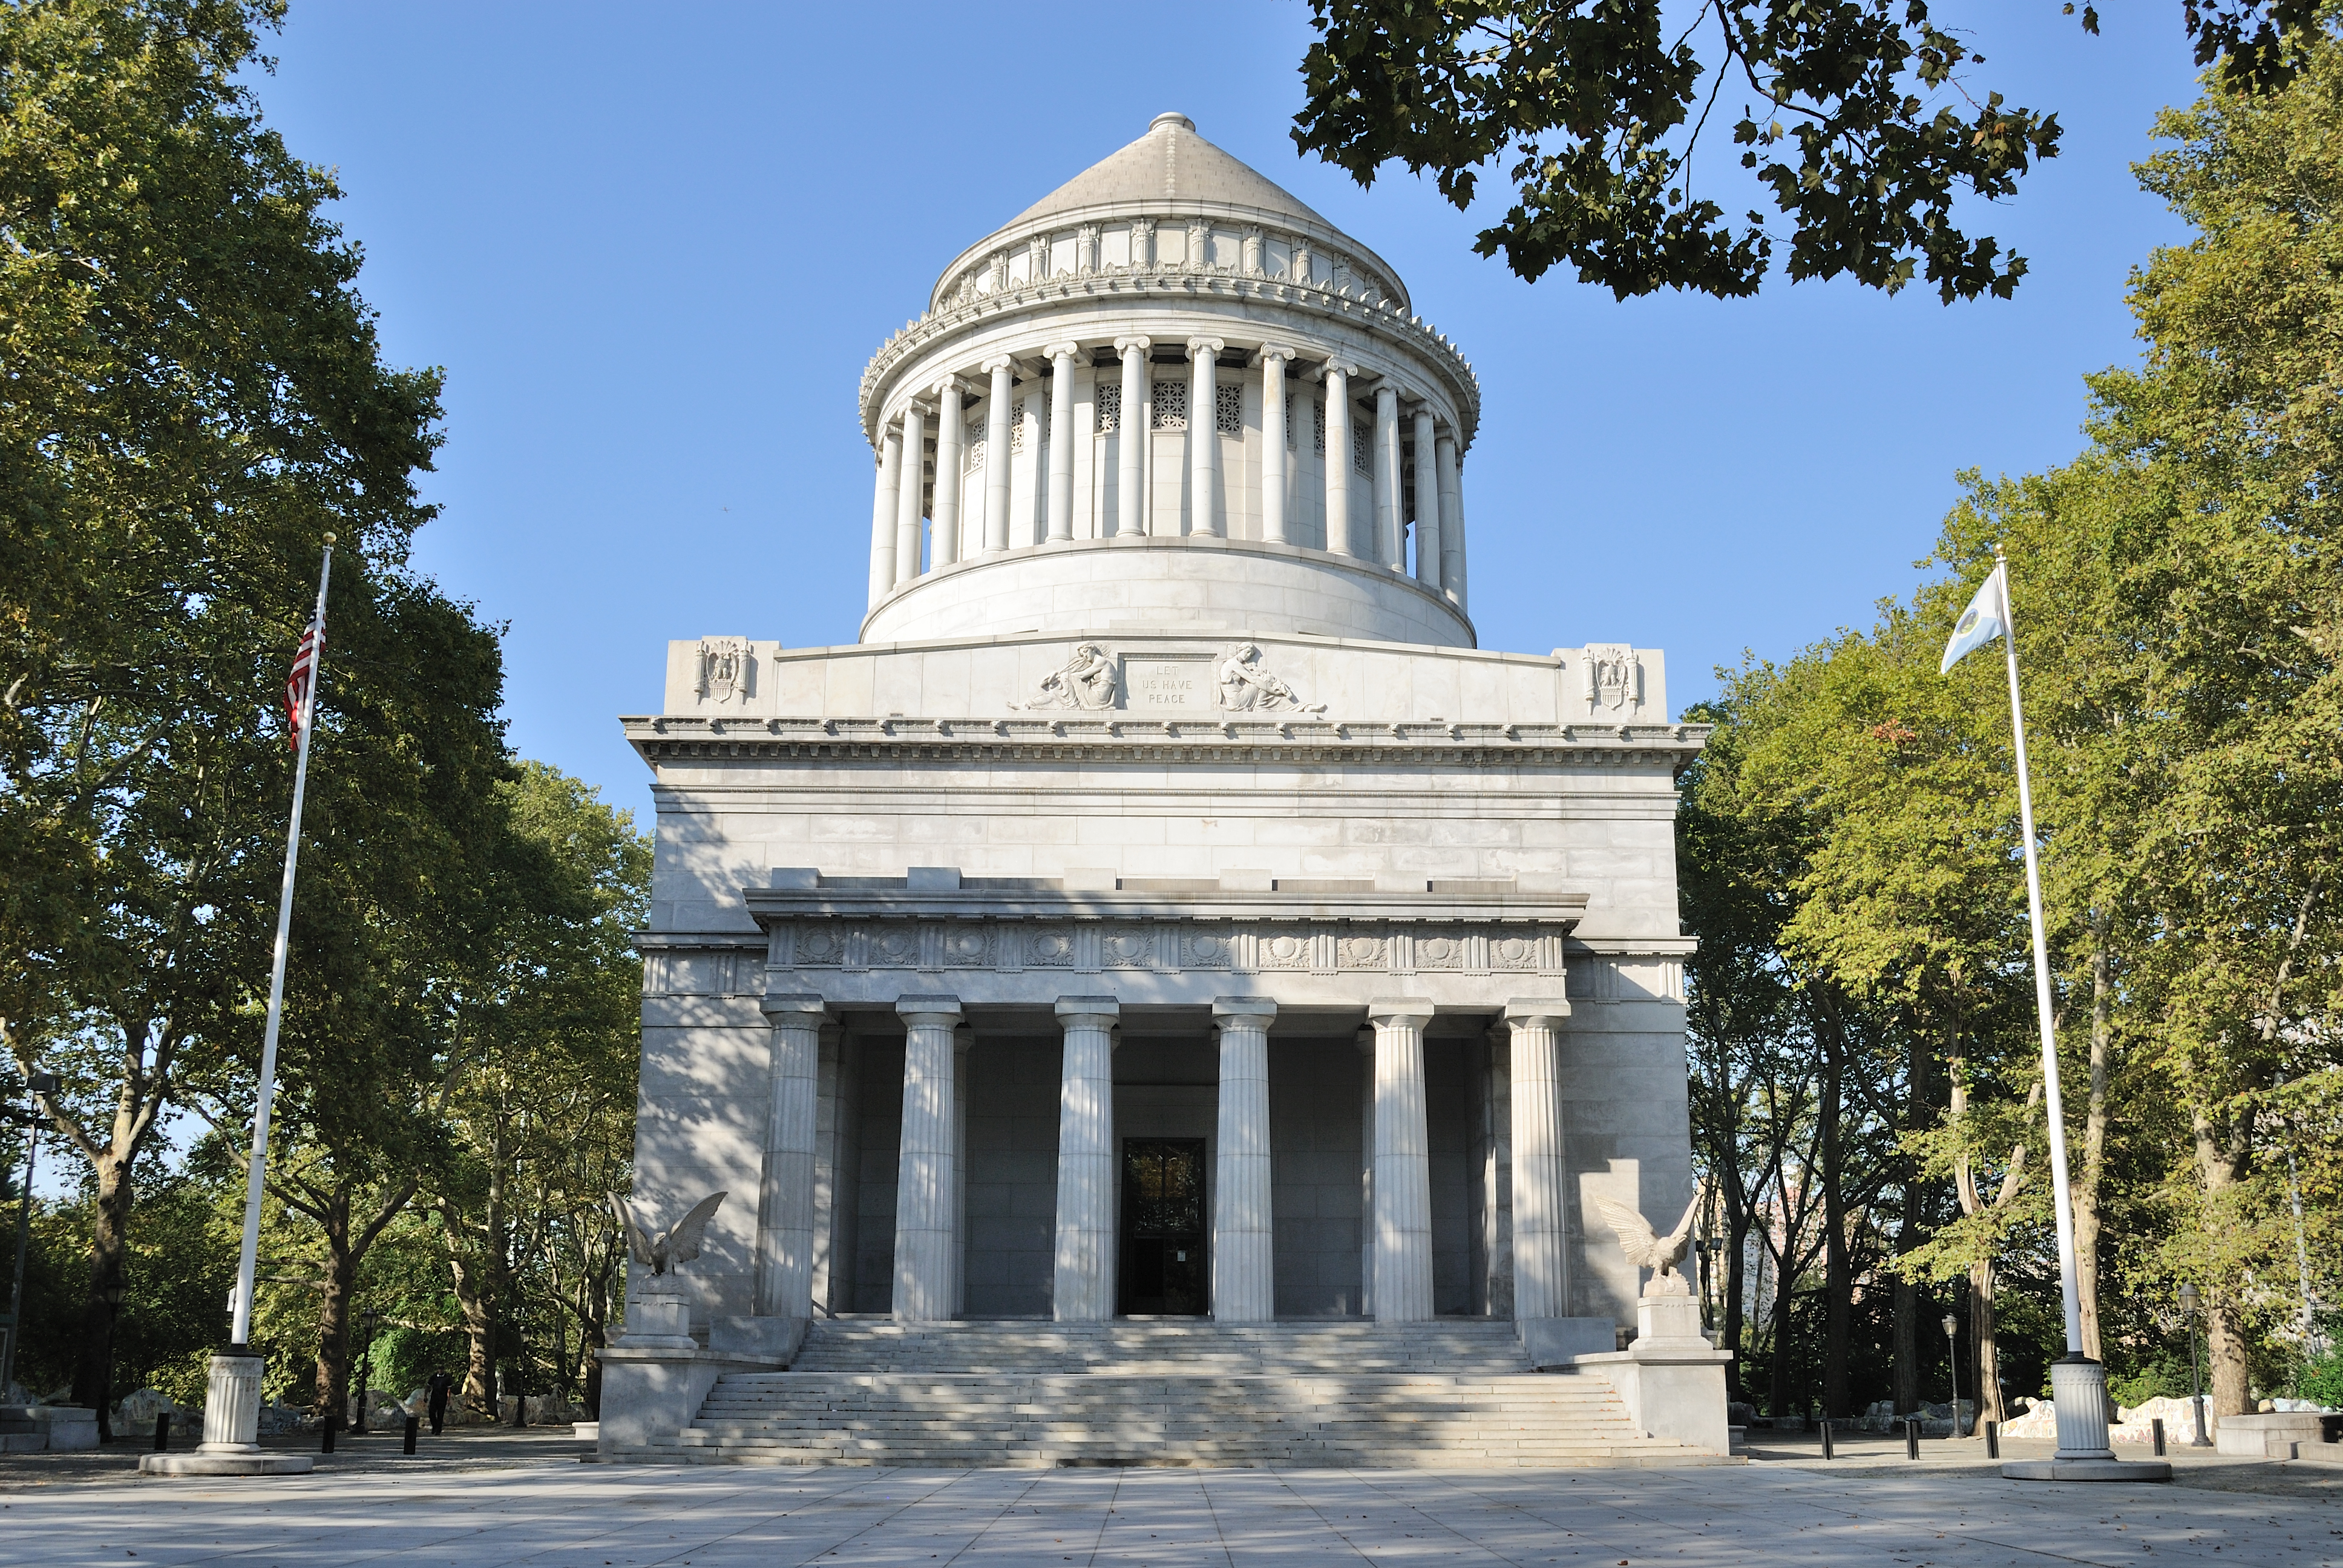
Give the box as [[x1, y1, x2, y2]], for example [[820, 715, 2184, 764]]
[[602, 115, 1725, 1463]]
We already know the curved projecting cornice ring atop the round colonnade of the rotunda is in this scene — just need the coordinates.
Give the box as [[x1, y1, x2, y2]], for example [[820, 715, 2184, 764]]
[[857, 263, 1481, 455]]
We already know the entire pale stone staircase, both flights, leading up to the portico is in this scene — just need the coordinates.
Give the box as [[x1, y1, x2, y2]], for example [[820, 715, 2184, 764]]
[[609, 1317, 1729, 1467]]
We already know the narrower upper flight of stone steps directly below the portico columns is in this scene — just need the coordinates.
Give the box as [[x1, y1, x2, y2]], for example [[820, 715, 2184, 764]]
[[790, 1317, 1530, 1376]]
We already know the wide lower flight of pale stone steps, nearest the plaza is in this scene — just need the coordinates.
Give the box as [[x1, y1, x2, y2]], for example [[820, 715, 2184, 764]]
[[637, 1371, 1722, 1469]]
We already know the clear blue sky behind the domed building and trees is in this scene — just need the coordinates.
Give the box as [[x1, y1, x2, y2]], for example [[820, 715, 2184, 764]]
[[258, 0, 2195, 825]]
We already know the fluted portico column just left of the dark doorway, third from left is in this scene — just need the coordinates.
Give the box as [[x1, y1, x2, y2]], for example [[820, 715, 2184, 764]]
[[1050, 996, 1122, 1322]]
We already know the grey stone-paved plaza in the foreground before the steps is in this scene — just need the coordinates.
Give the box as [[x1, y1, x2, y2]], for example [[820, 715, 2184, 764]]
[[0, 1446, 2343, 1568]]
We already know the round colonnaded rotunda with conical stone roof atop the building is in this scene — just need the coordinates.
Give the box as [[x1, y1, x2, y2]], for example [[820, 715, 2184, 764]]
[[860, 115, 1481, 647]]
